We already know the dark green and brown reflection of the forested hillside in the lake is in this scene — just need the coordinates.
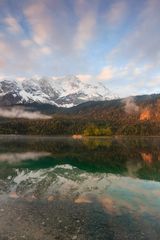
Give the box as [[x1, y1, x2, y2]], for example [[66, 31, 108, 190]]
[[0, 137, 160, 178]]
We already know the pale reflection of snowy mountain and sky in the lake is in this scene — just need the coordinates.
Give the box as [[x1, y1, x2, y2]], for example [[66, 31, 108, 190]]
[[1, 165, 160, 216]]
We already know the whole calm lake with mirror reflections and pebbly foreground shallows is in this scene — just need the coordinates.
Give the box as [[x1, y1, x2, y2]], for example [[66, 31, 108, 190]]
[[0, 136, 160, 240]]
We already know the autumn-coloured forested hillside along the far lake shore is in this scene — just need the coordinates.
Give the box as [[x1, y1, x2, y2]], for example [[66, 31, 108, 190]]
[[0, 94, 160, 136]]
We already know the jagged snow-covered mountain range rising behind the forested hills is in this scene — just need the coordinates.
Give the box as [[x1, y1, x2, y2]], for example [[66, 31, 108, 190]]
[[0, 76, 114, 107]]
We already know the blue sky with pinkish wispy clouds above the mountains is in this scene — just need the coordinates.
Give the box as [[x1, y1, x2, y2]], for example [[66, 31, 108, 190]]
[[0, 0, 160, 97]]
